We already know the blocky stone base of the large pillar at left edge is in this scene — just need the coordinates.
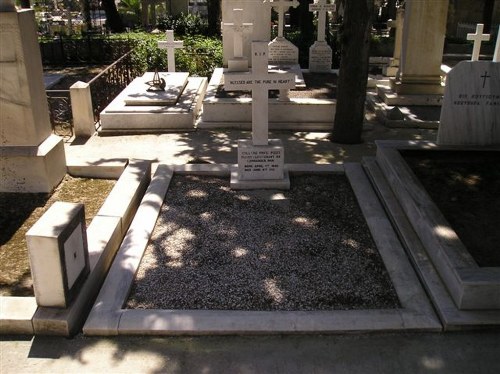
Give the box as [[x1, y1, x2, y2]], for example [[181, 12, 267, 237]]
[[0, 135, 66, 193]]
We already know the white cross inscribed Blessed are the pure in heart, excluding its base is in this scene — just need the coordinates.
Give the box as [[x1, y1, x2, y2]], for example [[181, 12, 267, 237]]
[[224, 42, 295, 145]]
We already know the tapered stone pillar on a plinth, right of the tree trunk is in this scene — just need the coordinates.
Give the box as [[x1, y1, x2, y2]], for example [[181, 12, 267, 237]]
[[391, 0, 449, 95]]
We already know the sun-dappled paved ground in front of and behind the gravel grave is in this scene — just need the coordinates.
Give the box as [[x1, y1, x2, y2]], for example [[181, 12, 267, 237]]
[[0, 124, 500, 374]]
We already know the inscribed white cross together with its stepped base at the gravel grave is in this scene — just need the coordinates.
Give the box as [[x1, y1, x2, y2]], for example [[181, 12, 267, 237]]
[[224, 42, 295, 189]]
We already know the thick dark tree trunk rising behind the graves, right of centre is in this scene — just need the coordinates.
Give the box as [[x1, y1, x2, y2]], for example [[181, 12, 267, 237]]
[[330, 0, 374, 144]]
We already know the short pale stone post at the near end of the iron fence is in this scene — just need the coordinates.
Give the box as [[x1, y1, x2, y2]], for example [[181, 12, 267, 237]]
[[69, 82, 95, 138]]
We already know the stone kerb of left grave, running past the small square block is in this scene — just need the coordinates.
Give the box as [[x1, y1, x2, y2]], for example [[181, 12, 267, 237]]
[[0, 159, 150, 336]]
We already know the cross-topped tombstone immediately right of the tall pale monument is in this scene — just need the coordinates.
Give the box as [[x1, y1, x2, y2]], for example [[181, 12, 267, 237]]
[[269, 0, 299, 65]]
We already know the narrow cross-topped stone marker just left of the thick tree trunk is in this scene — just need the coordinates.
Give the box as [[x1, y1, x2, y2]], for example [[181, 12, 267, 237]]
[[309, 0, 336, 73]]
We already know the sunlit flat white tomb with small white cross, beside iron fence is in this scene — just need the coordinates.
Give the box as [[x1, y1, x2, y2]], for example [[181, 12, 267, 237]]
[[99, 30, 207, 135]]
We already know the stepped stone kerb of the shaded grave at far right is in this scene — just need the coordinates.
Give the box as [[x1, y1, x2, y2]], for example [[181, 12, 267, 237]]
[[364, 141, 500, 330]]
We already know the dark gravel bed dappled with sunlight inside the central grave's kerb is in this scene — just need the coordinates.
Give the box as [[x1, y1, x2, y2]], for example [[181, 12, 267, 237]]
[[126, 174, 400, 311]]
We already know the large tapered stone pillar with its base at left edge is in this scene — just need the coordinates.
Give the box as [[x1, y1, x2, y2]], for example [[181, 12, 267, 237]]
[[0, 9, 66, 192]]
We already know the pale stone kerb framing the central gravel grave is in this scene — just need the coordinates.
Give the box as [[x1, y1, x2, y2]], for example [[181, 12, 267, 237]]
[[83, 164, 442, 335]]
